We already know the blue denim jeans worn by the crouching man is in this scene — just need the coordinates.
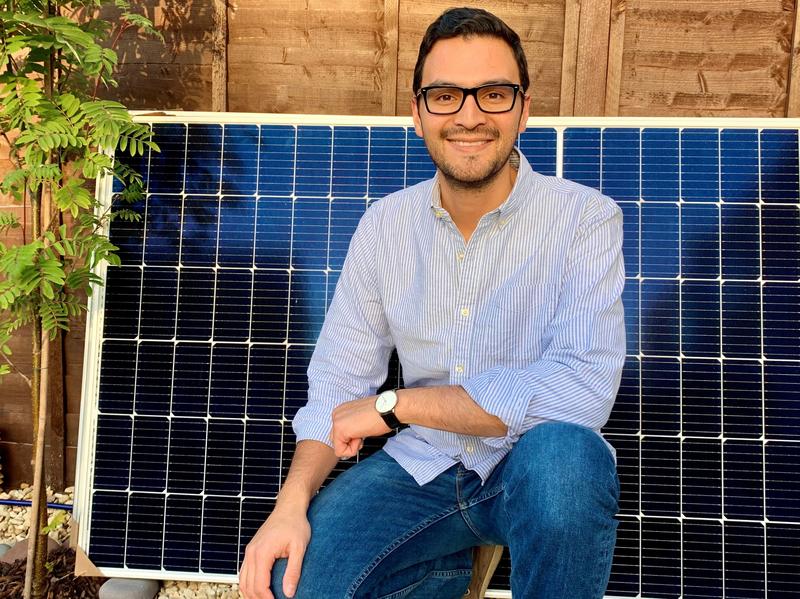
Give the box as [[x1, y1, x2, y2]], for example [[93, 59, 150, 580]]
[[272, 423, 619, 599]]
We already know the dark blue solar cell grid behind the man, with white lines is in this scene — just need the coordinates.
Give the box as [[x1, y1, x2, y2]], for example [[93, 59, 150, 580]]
[[79, 120, 800, 599]]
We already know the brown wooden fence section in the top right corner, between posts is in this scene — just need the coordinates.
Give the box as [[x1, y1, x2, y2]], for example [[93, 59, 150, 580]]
[[619, 0, 795, 116]]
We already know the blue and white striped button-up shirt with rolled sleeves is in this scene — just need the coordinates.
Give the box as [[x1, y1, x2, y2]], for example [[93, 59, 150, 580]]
[[293, 154, 625, 484]]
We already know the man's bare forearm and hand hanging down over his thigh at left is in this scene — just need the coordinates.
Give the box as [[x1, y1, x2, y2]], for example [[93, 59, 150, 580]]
[[239, 441, 338, 599]]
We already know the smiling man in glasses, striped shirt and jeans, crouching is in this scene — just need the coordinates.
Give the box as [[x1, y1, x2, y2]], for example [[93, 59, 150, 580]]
[[240, 8, 625, 599]]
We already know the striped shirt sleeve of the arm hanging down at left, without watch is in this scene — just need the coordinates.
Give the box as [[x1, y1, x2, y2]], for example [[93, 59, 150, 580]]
[[292, 208, 394, 446]]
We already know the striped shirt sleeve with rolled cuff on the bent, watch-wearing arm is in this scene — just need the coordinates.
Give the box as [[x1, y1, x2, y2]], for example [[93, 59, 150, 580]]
[[462, 196, 625, 448]]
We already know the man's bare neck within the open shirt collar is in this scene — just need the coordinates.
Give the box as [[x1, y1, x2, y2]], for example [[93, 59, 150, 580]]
[[439, 160, 518, 246]]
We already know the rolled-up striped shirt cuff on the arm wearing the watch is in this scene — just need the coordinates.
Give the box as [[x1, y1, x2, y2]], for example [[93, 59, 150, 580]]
[[461, 366, 530, 449]]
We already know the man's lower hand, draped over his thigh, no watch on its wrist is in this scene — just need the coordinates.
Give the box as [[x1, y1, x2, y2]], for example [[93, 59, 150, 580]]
[[239, 511, 311, 599]]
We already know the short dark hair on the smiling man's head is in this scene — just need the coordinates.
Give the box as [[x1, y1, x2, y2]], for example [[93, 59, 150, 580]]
[[413, 7, 531, 93]]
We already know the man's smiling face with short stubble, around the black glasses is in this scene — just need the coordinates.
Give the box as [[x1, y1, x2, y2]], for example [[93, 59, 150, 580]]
[[411, 36, 530, 188]]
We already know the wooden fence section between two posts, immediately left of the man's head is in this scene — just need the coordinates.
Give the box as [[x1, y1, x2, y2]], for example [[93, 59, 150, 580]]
[[228, 0, 388, 114]]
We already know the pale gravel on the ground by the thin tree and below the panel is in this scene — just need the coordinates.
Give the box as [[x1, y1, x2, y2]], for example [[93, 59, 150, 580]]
[[0, 483, 242, 599]]
